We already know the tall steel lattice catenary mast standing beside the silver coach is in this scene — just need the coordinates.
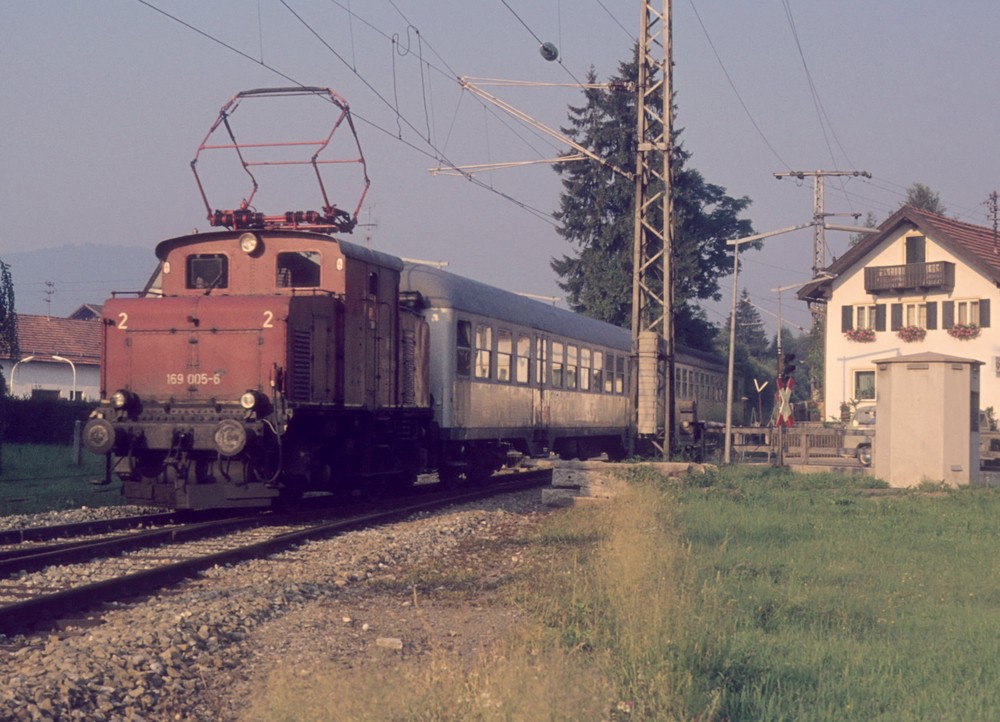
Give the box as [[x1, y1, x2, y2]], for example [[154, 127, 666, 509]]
[[629, 0, 675, 457]]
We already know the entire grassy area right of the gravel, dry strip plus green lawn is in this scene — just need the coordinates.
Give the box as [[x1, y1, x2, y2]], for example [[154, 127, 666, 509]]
[[260, 469, 1000, 722]]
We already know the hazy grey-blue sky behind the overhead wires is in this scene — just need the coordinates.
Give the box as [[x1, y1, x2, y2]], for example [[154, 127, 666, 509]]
[[0, 0, 1000, 334]]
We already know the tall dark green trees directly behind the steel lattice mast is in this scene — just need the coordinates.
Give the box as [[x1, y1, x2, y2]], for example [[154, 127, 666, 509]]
[[552, 50, 753, 349]]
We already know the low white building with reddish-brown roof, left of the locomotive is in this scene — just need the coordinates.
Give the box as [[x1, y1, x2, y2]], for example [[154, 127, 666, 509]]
[[0, 314, 101, 401]]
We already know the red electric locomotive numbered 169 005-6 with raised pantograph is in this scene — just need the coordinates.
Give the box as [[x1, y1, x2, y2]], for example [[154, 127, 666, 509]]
[[84, 88, 431, 508]]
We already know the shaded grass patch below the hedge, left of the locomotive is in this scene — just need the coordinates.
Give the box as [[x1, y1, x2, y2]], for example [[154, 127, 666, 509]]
[[0, 444, 122, 514]]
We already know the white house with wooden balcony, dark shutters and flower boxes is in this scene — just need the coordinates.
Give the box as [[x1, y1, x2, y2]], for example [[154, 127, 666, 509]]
[[798, 206, 1000, 418]]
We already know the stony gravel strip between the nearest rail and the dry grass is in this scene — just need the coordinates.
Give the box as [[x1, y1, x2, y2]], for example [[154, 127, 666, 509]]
[[0, 490, 543, 721]]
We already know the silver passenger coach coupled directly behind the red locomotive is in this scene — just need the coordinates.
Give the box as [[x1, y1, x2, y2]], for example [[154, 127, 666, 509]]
[[400, 263, 631, 475]]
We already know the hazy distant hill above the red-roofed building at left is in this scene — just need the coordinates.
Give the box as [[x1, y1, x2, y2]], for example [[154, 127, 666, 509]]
[[0, 243, 156, 317]]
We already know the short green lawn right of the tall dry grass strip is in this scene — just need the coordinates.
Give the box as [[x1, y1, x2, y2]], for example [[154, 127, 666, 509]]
[[678, 473, 1000, 722]]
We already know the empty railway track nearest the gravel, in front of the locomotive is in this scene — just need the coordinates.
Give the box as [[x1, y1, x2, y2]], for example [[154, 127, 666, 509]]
[[0, 472, 550, 635]]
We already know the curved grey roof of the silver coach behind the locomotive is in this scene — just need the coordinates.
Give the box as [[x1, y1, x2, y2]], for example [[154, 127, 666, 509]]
[[399, 262, 632, 350]]
